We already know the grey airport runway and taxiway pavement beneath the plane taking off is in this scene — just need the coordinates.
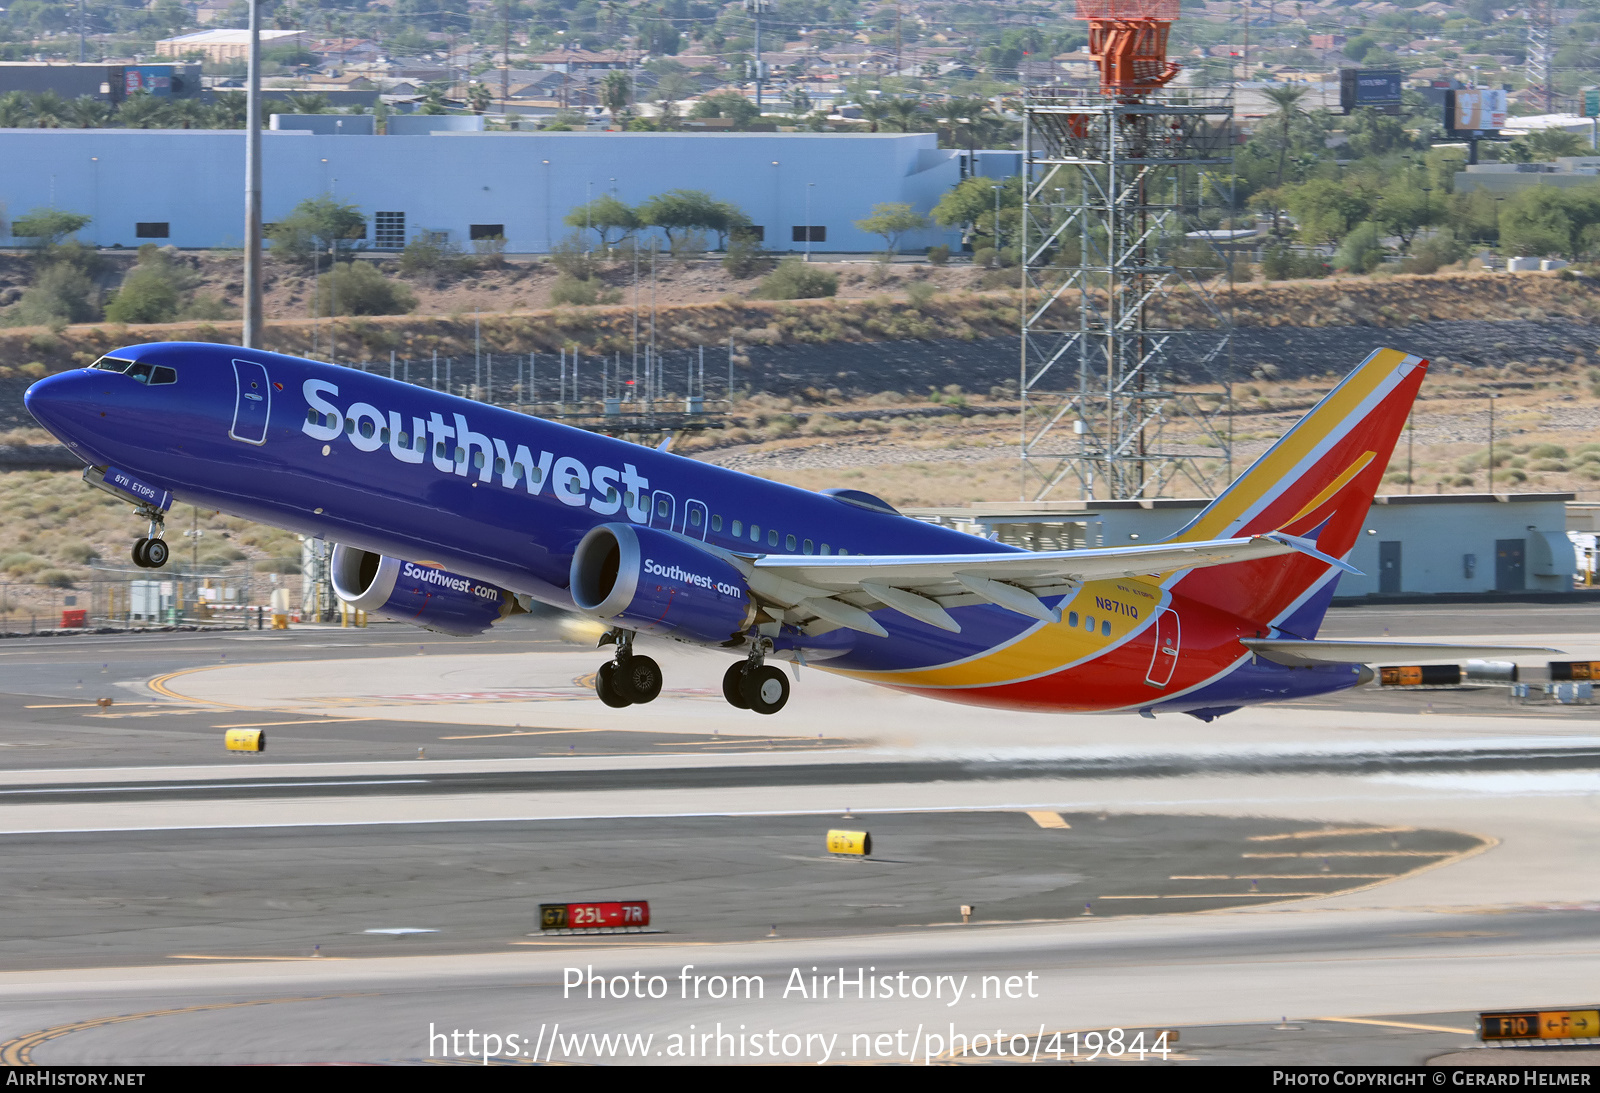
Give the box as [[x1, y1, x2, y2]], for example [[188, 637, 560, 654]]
[[0, 605, 1600, 1066]]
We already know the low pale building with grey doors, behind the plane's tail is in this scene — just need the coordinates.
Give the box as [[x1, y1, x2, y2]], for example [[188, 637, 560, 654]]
[[907, 493, 1579, 597]]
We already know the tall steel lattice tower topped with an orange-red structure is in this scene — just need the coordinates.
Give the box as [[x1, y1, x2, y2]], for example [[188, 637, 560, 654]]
[[1019, 0, 1234, 499]]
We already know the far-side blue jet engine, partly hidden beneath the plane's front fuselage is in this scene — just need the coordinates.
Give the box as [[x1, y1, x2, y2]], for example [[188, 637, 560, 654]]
[[330, 544, 523, 637]]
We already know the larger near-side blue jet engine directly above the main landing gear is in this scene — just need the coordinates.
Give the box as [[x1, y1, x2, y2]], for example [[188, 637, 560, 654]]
[[571, 523, 755, 643]]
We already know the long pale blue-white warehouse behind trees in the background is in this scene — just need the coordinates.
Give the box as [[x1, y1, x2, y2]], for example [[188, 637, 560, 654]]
[[0, 126, 960, 253]]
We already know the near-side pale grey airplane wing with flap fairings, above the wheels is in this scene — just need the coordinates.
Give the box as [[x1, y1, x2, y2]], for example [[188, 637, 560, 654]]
[[733, 533, 1354, 637]]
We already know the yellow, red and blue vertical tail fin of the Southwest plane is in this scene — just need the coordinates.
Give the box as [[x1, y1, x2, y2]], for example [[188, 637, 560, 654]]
[[1173, 349, 1427, 637]]
